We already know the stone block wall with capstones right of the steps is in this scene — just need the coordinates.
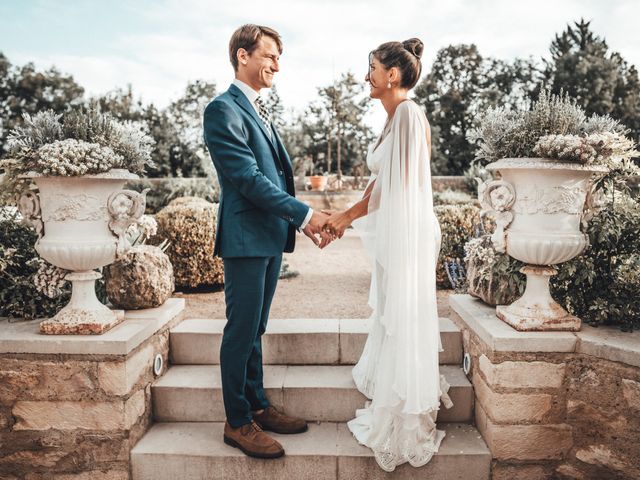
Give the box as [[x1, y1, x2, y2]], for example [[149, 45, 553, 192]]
[[451, 295, 640, 480]]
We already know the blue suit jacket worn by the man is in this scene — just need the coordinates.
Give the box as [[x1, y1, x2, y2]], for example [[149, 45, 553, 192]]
[[204, 85, 309, 258]]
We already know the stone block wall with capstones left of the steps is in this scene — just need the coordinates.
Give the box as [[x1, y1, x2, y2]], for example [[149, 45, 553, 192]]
[[0, 298, 184, 480]]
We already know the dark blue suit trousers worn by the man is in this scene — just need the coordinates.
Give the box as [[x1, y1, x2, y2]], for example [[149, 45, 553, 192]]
[[220, 254, 282, 428]]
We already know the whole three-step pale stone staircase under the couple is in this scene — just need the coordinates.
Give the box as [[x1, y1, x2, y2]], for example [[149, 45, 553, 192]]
[[131, 318, 491, 480]]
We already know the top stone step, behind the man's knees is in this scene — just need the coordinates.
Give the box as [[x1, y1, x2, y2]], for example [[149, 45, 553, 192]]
[[170, 318, 462, 365]]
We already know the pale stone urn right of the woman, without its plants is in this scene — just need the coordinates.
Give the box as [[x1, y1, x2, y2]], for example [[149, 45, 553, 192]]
[[478, 158, 607, 331]]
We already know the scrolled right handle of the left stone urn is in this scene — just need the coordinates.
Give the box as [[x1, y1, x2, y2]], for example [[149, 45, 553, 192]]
[[107, 188, 150, 257]]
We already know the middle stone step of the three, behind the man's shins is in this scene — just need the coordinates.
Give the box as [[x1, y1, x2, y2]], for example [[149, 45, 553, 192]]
[[151, 365, 474, 422]]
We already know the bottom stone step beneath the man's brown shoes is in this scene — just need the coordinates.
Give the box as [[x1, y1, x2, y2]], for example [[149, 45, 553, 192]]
[[131, 423, 491, 480]]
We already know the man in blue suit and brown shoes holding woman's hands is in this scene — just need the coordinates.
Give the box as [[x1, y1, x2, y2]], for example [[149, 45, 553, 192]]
[[204, 25, 330, 458]]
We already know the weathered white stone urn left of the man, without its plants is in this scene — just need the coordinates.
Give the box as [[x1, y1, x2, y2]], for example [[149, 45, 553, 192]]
[[18, 169, 147, 334]]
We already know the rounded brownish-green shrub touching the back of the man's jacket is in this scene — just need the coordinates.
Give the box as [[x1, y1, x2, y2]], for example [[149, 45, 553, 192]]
[[149, 197, 224, 287]]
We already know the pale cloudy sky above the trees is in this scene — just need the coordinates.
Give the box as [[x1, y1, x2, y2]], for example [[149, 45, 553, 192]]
[[0, 0, 640, 127]]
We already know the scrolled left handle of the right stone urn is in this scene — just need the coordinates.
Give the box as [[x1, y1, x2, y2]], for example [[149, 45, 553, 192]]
[[476, 178, 516, 253]]
